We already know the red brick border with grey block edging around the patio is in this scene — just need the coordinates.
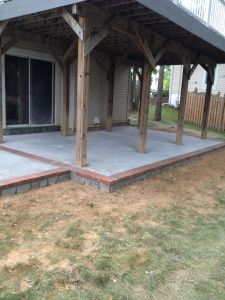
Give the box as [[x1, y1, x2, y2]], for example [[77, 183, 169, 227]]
[[0, 143, 225, 196]]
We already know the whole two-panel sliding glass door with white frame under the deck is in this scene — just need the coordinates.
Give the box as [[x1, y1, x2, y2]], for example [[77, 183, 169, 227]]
[[5, 55, 54, 126]]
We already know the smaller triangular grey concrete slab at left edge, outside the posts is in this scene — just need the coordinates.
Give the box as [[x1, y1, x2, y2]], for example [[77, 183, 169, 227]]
[[0, 150, 55, 181]]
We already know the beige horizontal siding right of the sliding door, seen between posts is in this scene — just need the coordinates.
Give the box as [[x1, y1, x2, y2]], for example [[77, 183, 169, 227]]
[[69, 58, 129, 129]]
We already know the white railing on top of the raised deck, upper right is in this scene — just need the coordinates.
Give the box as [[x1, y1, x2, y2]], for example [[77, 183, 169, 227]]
[[171, 0, 225, 37]]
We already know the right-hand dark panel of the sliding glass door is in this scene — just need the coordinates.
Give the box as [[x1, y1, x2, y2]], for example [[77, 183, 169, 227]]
[[30, 59, 53, 125]]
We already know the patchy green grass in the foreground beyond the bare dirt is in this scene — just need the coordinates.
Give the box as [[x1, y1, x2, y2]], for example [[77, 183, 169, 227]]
[[0, 202, 225, 300]]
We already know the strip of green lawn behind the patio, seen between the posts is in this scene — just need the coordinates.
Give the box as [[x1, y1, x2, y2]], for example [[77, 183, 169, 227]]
[[129, 105, 225, 139]]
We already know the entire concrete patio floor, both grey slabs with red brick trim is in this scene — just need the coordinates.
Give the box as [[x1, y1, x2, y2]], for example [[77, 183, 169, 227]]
[[0, 127, 225, 195]]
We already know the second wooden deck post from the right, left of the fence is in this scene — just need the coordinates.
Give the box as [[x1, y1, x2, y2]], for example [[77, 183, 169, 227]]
[[176, 64, 190, 145]]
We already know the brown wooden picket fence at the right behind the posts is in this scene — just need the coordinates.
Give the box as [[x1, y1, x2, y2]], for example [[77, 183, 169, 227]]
[[185, 93, 225, 131]]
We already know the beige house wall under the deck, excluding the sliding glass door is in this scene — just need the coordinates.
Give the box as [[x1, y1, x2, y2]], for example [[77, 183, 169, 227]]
[[2, 44, 129, 130]]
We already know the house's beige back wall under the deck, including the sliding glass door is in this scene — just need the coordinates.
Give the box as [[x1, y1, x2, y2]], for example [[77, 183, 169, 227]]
[[2, 43, 129, 134]]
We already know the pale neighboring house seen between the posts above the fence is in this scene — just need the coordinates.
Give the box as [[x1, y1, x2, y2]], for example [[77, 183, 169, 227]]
[[169, 64, 225, 105]]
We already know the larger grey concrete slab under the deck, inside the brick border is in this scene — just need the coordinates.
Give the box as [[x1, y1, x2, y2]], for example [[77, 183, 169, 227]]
[[4, 127, 221, 175]]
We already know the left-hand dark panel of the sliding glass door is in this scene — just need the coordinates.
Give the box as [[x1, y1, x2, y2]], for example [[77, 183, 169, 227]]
[[5, 55, 29, 125]]
